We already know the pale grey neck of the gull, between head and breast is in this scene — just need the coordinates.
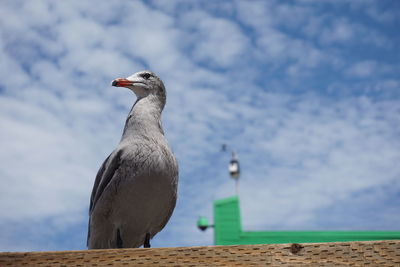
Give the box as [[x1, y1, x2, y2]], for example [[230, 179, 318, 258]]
[[121, 95, 164, 140]]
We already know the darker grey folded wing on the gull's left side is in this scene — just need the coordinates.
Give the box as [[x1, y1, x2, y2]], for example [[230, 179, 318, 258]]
[[87, 150, 122, 244]]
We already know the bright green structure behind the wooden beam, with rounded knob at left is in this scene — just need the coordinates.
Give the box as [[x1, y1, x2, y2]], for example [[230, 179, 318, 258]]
[[198, 196, 400, 245]]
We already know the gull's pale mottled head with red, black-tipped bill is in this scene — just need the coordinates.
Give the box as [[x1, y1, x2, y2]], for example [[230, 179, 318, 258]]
[[111, 70, 166, 103]]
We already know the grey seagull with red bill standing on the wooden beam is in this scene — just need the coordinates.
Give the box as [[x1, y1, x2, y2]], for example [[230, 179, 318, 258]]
[[87, 71, 178, 249]]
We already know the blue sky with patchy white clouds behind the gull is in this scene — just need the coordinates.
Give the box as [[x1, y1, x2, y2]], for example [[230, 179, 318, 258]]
[[0, 0, 400, 251]]
